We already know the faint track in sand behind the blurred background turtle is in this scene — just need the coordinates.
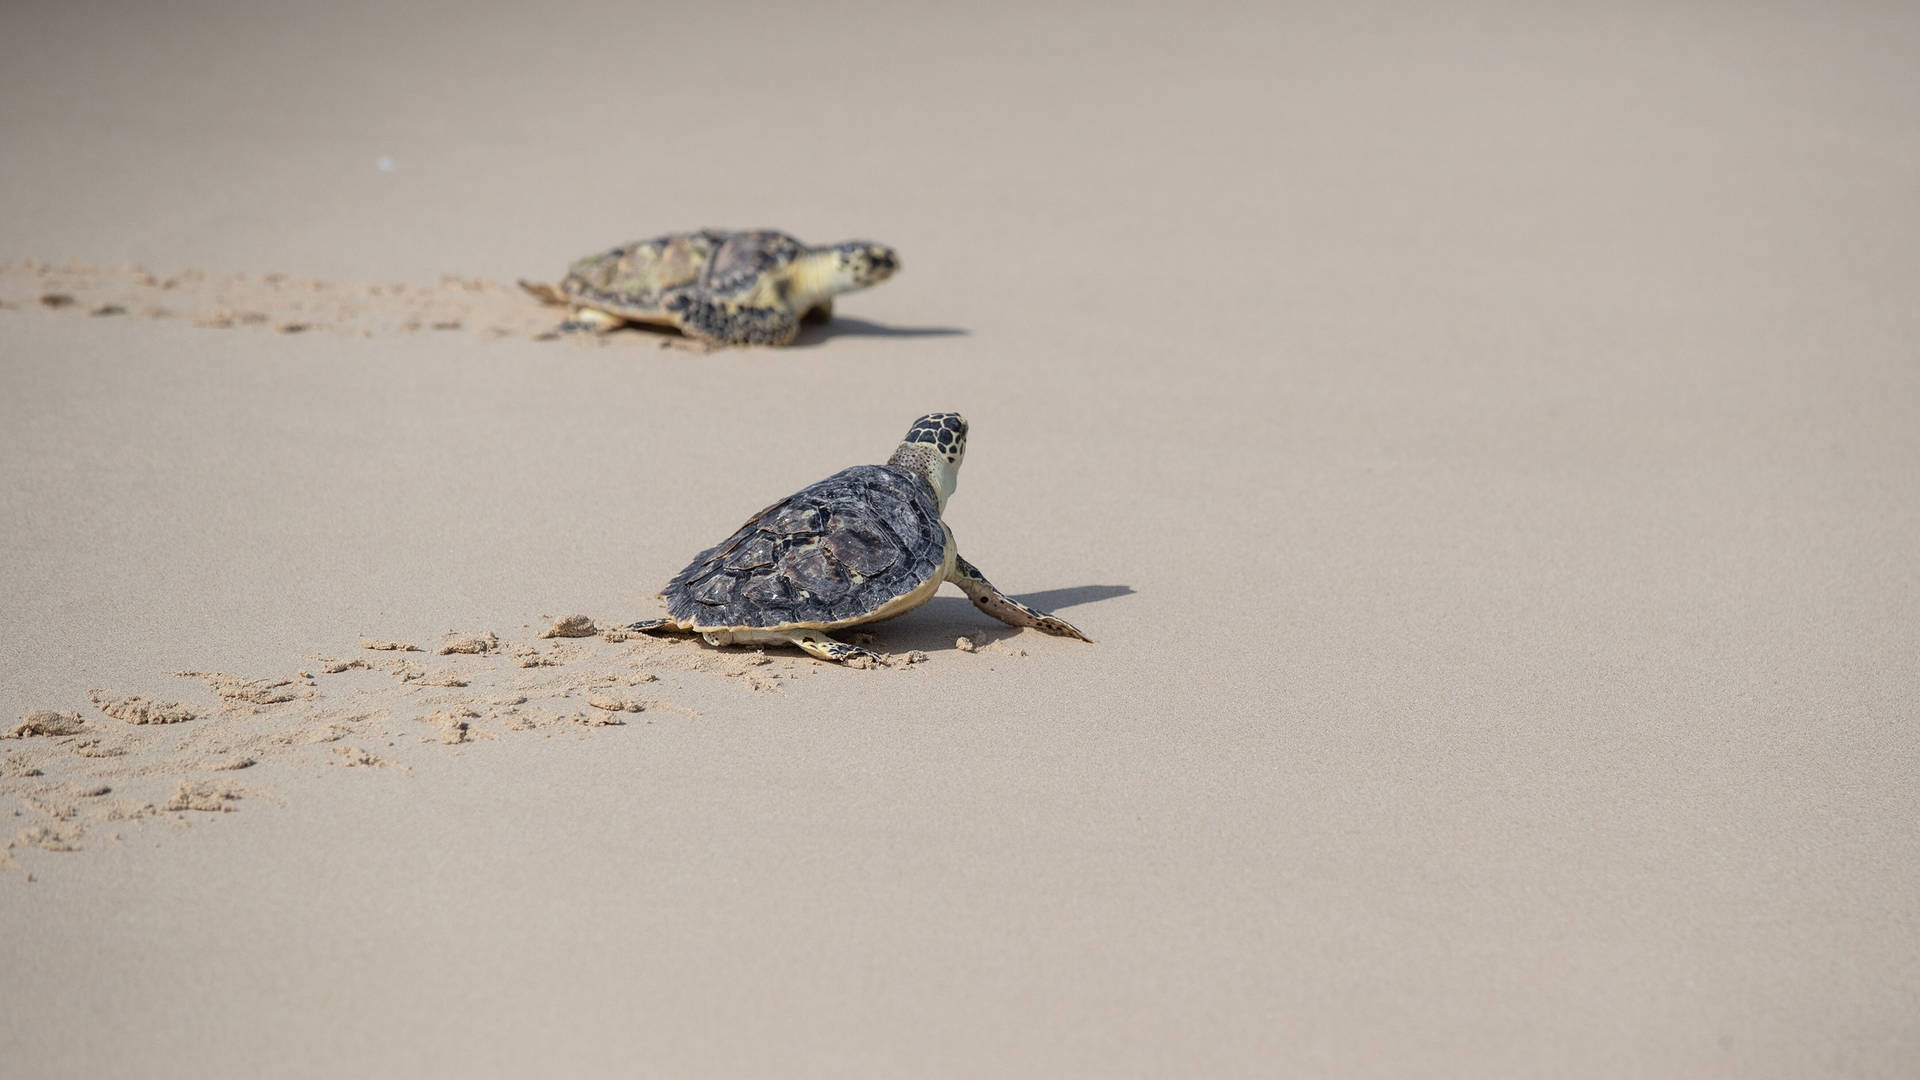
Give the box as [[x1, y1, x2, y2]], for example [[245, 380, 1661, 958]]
[[0, 259, 708, 352]]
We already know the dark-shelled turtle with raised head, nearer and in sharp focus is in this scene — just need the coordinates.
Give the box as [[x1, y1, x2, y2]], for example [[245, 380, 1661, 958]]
[[628, 413, 1092, 661]]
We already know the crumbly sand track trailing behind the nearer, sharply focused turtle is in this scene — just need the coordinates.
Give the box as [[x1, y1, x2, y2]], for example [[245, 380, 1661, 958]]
[[0, 615, 1023, 880]]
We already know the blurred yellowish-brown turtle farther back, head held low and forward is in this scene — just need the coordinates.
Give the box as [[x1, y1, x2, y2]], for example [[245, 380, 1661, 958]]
[[520, 229, 900, 346]]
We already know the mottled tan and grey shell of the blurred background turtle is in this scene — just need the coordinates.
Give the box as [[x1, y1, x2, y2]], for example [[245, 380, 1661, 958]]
[[561, 229, 808, 319]]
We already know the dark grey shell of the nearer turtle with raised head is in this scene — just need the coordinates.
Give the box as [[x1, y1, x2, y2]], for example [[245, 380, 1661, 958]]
[[660, 465, 947, 630]]
